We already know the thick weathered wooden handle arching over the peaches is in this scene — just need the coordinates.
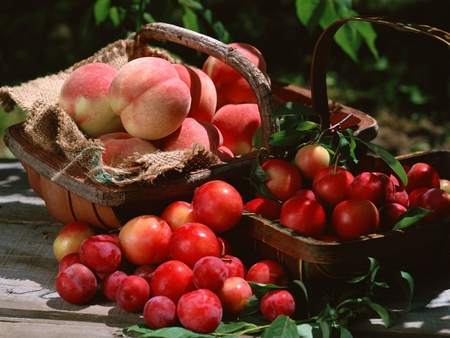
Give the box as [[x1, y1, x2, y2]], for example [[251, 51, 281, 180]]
[[130, 22, 280, 153]]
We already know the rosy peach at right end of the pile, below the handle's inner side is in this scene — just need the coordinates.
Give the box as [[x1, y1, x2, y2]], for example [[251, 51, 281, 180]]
[[212, 103, 261, 156]]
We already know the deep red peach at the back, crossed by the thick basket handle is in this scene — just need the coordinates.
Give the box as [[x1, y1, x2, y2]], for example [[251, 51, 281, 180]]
[[202, 43, 269, 108]]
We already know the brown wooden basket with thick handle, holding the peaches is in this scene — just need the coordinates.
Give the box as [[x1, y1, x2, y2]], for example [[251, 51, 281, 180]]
[[4, 23, 378, 229]]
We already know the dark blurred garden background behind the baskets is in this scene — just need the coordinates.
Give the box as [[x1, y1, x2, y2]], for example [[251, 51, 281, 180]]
[[0, 0, 450, 157]]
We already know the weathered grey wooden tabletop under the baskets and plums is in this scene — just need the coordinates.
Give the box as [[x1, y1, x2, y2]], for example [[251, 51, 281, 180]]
[[0, 160, 450, 337]]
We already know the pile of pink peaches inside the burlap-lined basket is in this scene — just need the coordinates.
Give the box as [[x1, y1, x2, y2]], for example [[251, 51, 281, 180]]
[[59, 43, 269, 166]]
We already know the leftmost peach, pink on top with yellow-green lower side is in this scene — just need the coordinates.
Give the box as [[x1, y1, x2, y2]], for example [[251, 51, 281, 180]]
[[59, 62, 124, 138]]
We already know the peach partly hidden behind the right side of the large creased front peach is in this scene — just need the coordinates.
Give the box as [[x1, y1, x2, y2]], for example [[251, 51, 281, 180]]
[[174, 65, 217, 122]]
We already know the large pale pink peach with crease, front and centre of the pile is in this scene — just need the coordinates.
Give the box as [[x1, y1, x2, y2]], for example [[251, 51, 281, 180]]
[[109, 57, 191, 140]]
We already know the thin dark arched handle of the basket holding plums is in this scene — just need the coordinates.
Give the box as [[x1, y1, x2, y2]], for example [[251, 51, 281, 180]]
[[311, 16, 450, 126]]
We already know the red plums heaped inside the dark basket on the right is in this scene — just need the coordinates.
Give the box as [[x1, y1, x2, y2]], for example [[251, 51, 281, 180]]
[[246, 144, 450, 241]]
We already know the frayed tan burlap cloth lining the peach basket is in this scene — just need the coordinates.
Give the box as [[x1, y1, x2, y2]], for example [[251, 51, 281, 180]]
[[0, 38, 220, 186]]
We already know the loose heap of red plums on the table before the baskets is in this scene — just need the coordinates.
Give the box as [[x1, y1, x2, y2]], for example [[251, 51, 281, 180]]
[[53, 180, 296, 333]]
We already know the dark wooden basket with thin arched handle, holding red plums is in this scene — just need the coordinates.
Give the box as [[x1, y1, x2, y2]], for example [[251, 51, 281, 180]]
[[230, 17, 450, 283]]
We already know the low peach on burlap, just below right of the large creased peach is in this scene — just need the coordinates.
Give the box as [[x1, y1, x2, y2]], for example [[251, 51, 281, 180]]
[[156, 117, 223, 151]]
